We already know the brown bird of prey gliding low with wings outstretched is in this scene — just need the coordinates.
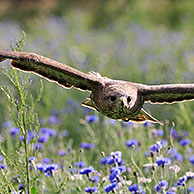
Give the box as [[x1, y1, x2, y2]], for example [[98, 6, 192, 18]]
[[0, 50, 194, 124]]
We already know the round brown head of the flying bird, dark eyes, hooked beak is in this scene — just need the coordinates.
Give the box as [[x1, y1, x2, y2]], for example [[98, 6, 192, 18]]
[[95, 82, 143, 120]]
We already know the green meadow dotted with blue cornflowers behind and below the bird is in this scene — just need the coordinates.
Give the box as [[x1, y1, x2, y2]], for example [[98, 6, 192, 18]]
[[0, 12, 194, 194]]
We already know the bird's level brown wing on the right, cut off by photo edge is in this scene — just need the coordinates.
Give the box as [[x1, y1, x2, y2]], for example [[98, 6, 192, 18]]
[[140, 84, 194, 104]]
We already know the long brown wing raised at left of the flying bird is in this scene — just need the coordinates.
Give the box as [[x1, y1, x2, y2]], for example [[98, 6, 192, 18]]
[[0, 50, 102, 91]]
